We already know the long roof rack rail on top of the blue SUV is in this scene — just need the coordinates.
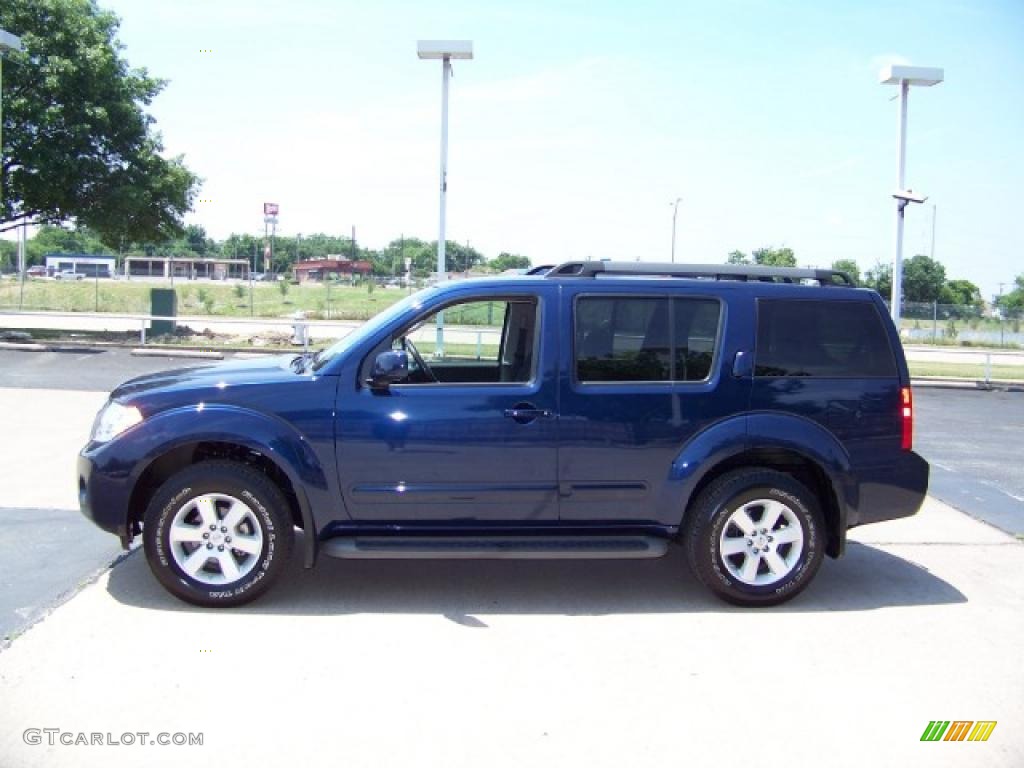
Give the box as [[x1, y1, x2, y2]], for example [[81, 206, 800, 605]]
[[547, 261, 854, 287]]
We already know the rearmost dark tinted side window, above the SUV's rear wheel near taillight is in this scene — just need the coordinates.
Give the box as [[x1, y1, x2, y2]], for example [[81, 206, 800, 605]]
[[754, 299, 896, 379]]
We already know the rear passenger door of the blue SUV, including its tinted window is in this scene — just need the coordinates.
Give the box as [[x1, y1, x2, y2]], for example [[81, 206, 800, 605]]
[[558, 282, 750, 524]]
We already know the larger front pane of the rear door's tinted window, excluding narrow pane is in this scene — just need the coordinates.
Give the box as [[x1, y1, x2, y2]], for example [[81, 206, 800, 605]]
[[575, 296, 672, 381]]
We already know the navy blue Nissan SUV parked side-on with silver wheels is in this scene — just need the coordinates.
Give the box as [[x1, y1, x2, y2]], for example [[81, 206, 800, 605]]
[[78, 262, 929, 605]]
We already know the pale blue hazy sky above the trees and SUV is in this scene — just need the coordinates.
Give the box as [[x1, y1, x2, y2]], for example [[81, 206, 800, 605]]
[[88, 0, 1024, 298]]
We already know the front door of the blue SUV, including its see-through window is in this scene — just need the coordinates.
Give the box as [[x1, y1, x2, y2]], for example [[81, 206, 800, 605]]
[[336, 286, 558, 524]]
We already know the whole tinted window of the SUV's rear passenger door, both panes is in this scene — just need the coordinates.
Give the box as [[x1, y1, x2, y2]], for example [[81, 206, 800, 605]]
[[575, 296, 720, 382]]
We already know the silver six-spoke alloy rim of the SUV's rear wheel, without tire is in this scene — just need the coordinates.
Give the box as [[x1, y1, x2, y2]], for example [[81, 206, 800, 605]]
[[719, 499, 804, 587]]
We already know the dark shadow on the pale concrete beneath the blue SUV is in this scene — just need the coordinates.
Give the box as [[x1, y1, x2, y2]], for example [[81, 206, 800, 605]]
[[108, 542, 967, 626]]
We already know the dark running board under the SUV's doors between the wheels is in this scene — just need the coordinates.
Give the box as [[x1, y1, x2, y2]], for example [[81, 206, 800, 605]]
[[321, 536, 669, 560]]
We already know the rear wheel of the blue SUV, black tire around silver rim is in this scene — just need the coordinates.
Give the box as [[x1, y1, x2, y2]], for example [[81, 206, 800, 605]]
[[683, 467, 825, 606]]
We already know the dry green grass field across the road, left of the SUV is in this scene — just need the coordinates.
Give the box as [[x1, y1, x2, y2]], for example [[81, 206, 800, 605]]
[[0, 280, 407, 319]]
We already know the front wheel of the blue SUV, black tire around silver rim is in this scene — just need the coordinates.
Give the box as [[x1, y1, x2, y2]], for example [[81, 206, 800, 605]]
[[142, 461, 295, 607]]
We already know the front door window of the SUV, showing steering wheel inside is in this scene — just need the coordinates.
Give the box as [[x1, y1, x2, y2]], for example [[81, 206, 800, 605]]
[[391, 297, 539, 384]]
